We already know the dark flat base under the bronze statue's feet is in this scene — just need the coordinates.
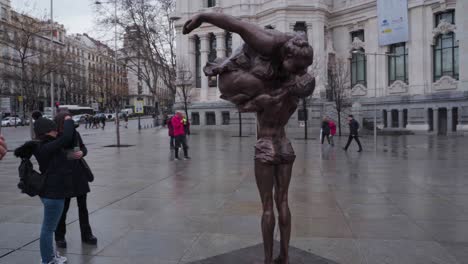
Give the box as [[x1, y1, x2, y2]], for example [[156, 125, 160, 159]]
[[188, 242, 339, 264]]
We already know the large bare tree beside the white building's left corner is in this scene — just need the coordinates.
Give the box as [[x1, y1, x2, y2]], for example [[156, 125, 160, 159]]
[[97, 0, 177, 111]]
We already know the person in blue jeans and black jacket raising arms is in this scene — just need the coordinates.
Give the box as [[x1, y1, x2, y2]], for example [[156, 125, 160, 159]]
[[15, 115, 74, 264]]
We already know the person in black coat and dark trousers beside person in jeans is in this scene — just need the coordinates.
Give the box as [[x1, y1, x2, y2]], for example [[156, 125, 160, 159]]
[[55, 112, 97, 248]]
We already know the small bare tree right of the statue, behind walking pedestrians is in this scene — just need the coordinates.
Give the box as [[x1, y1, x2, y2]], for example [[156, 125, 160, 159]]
[[328, 54, 351, 136]]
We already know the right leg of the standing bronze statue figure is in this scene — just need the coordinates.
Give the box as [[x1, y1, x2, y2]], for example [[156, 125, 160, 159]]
[[275, 163, 293, 264]]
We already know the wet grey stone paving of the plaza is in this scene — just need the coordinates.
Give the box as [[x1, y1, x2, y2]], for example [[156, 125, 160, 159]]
[[0, 123, 468, 264]]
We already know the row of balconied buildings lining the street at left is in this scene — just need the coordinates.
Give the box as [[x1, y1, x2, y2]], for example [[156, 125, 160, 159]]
[[0, 0, 128, 115]]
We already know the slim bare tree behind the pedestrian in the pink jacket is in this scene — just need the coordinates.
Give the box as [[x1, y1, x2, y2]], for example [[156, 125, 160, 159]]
[[176, 59, 193, 118]]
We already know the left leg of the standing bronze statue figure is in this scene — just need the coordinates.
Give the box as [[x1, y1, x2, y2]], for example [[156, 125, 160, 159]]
[[255, 161, 275, 264]]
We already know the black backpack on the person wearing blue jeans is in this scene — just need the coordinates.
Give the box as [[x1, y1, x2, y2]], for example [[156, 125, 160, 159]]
[[18, 158, 46, 197]]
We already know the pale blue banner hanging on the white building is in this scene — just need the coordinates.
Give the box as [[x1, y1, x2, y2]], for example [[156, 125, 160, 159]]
[[377, 0, 409, 46]]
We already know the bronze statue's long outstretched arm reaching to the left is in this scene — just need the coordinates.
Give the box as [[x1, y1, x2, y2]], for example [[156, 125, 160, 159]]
[[183, 13, 288, 56]]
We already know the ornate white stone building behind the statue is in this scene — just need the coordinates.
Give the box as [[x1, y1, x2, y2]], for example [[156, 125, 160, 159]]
[[173, 0, 468, 134]]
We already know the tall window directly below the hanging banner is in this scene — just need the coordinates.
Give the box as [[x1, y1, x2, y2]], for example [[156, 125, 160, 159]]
[[388, 43, 408, 85]]
